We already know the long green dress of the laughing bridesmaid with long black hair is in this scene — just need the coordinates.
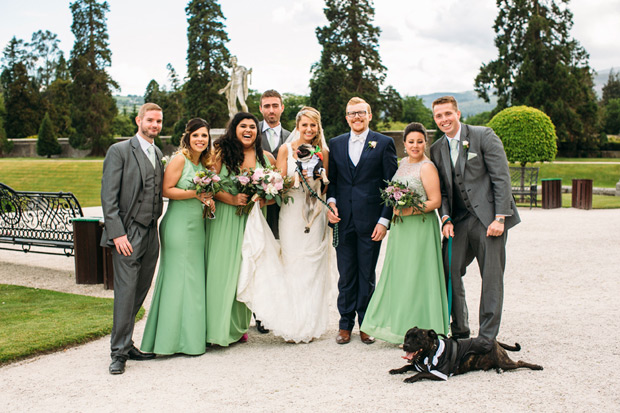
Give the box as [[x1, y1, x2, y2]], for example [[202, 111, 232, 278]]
[[203, 158, 269, 346]]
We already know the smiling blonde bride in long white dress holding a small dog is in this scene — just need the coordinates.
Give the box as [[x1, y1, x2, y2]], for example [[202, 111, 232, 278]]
[[237, 107, 336, 343]]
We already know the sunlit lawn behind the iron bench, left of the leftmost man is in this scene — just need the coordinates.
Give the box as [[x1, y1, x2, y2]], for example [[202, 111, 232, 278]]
[[0, 158, 103, 207]]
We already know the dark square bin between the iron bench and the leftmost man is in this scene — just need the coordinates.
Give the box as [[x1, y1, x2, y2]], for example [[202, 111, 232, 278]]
[[71, 217, 103, 284]]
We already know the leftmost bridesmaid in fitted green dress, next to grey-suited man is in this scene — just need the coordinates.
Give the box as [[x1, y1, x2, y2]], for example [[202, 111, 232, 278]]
[[141, 118, 215, 355]]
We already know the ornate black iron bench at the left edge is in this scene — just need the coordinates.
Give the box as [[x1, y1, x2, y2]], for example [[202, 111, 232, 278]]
[[0, 183, 84, 257]]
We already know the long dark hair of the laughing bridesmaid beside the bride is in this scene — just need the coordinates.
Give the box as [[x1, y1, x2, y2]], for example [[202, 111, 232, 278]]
[[213, 112, 266, 174]]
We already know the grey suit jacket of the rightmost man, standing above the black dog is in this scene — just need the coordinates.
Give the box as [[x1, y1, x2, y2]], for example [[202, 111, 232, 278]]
[[430, 123, 521, 229]]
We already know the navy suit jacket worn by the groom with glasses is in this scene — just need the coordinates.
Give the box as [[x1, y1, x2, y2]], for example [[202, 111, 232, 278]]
[[327, 131, 398, 235]]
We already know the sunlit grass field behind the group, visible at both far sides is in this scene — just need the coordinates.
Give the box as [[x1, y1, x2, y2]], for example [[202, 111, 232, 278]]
[[0, 158, 620, 208]]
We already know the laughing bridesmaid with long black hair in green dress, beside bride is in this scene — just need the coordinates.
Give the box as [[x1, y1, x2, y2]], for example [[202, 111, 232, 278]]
[[206, 112, 275, 346]]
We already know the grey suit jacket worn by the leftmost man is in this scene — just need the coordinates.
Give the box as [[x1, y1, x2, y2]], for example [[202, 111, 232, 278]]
[[101, 136, 163, 247]]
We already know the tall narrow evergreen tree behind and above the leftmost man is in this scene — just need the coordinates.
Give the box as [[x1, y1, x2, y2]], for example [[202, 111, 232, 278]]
[[69, 0, 118, 155]]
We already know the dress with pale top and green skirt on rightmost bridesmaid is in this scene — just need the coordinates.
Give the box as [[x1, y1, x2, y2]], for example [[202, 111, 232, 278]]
[[360, 158, 449, 344]]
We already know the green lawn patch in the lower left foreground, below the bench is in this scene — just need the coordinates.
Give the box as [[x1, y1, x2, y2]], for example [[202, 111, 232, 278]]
[[0, 284, 144, 365]]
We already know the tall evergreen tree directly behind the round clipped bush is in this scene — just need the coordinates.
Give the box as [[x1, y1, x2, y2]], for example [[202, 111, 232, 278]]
[[475, 0, 599, 154]]
